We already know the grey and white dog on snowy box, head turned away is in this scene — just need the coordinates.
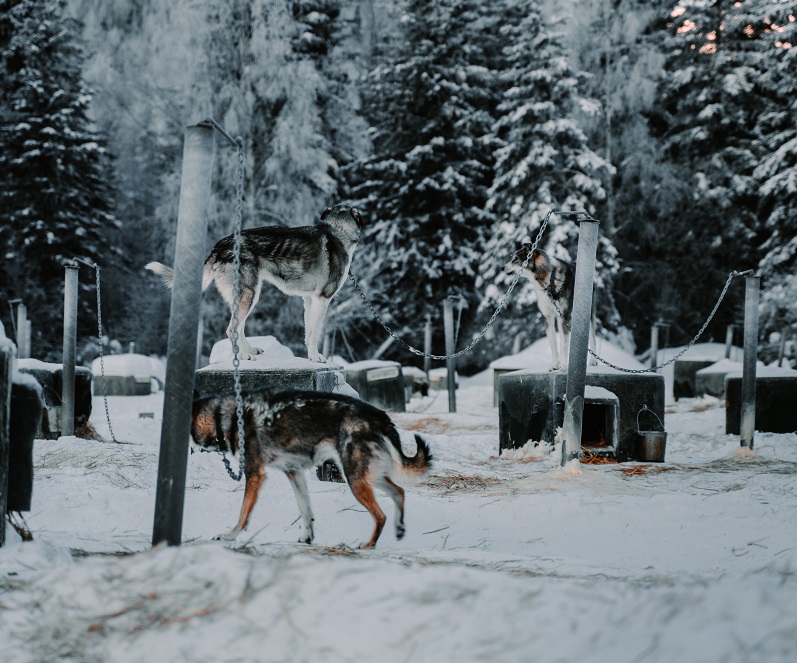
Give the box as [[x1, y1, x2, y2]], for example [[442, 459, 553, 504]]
[[146, 205, 362, 363]]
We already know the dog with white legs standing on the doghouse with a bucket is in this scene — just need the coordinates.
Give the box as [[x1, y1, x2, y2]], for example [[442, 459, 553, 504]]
[[506, 244, 597, 371]]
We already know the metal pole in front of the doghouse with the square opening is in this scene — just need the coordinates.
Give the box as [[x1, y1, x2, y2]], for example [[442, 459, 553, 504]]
[[562, 220, 599, 465]]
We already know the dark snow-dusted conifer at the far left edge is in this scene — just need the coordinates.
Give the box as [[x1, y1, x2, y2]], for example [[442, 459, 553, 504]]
[[0, 0, 118, 355]]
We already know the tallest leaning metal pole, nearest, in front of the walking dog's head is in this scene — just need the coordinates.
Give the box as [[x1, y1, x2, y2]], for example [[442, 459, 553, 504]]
[[152, 124, 213, 546]]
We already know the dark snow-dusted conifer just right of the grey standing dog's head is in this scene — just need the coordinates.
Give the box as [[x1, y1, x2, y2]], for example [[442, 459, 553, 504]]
[[350, 0, 496, 366]]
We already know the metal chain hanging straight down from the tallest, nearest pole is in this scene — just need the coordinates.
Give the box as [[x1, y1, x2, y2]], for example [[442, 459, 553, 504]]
[[221, 136, 246, 481]]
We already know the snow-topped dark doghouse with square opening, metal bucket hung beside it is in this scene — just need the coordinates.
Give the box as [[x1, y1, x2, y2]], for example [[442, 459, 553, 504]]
[[498, 339, 664, 462]]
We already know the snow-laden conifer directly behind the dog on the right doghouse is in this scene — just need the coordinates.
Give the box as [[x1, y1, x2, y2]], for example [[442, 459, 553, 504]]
[[472, 0, 618, 364]]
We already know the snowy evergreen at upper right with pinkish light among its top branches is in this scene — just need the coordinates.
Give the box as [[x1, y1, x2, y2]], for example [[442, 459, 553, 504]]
[[651, 0, 794, 348]]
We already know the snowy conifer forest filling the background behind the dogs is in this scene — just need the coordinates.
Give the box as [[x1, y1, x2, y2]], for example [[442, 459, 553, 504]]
[[0, 0, 797, 374]]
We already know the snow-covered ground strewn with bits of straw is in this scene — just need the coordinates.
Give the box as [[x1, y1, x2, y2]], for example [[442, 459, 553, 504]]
[[0, 358, 797, 663]]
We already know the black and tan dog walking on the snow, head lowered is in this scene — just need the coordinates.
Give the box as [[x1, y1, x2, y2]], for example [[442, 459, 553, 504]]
[[191, 391, 432, 548]]
